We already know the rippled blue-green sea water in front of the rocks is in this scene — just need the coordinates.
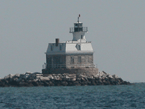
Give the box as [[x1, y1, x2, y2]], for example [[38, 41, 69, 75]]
[[0, 83, 145, 109]]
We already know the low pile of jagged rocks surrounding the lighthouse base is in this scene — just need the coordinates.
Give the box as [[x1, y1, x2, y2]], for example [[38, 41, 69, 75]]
[[0, 71, 130, 87]]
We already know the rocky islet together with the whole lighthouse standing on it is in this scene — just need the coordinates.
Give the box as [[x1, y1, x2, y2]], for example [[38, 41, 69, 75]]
[[0, 15, 130, 87]]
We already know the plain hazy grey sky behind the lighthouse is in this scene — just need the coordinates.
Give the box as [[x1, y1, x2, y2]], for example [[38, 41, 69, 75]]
[[0, 0, 145, 82]]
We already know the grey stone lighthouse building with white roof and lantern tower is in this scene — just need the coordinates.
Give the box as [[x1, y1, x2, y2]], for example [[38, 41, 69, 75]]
[[42, 15, 95, 74]]
